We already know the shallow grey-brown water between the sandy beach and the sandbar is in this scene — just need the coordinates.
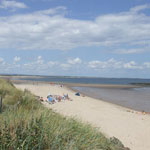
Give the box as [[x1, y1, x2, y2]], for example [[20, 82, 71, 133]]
[[73, 87, 150, 112]]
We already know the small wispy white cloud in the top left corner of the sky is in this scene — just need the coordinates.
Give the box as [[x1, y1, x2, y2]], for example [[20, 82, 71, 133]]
[[0, 0, 27, 11]]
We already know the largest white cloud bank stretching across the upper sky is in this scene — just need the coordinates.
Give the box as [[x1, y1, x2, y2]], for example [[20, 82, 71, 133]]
[[0, 5, 150, 50]]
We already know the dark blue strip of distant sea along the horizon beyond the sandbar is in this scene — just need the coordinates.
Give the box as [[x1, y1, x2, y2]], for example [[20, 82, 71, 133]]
[[19, 76, 150, 84]]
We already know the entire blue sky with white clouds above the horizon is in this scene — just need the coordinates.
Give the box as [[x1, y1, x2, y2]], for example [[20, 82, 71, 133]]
[[0, 0, 150, 78]]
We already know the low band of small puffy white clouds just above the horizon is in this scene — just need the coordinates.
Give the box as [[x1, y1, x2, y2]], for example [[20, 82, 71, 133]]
[[0, 56, 150, 75]]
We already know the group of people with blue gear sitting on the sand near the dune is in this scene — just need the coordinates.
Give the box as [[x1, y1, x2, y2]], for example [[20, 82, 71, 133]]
[[40, 94, 72, 104]]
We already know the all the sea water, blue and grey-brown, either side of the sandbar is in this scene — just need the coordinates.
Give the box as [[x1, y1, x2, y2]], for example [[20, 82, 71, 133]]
[[19, 76, 150, 112]]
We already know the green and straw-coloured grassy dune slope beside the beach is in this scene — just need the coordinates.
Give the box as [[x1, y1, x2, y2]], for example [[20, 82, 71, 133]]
[[0, 79, 129, 150]]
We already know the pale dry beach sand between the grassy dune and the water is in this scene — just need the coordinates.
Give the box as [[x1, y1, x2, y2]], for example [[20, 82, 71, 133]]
[[15, 82, 150, 150]]
